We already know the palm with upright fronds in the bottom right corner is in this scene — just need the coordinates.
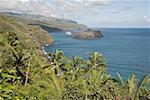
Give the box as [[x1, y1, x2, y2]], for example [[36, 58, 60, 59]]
[[117, 73, 150, 100]]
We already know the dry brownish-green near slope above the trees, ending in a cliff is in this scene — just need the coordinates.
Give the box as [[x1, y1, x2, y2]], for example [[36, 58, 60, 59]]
[[0, 14, 53, 45]]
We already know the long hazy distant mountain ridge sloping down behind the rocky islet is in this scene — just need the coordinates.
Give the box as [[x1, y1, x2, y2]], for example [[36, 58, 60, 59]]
[[0, 12, 88, 30]]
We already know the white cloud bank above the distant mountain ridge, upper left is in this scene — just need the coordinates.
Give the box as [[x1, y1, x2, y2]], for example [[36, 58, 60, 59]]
[[0, 0, 110, 19]]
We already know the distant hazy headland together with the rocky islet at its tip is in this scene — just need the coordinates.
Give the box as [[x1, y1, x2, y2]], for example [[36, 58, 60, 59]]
[[0, 12, 103, 39]]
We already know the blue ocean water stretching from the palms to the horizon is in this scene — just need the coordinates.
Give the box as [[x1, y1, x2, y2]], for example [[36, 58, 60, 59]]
[[45, 28, 150, 78]]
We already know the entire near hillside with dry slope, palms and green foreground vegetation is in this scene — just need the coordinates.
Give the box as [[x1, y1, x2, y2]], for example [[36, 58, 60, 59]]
[[0, 14, 150, 100]]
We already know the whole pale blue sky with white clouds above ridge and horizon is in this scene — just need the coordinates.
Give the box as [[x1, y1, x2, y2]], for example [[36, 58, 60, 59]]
[[0, 0, 150, 28]]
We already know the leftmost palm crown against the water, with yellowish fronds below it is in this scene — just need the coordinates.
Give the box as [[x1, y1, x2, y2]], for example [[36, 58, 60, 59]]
[[43, 50, 64, 97]]
